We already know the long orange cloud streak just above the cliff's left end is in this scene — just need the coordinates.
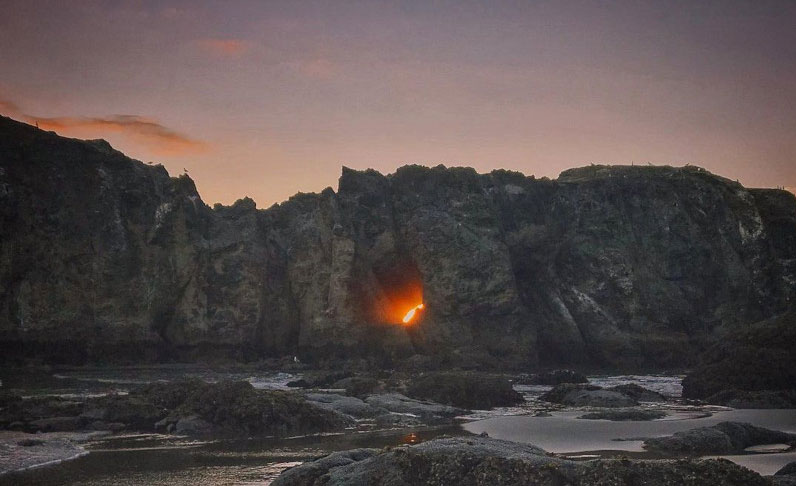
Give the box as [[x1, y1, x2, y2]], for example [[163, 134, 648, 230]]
[[25, 115, 207, 155]]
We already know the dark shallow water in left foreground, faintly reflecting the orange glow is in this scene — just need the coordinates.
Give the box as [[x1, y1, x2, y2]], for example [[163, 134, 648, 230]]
[[0, 427, 465, 486]]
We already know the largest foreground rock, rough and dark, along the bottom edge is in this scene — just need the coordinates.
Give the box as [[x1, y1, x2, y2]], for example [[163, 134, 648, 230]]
[[273, 437, 770, 486]]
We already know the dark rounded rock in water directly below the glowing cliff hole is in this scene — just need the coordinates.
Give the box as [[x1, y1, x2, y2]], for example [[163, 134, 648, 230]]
[[407, 372, 525, 409]]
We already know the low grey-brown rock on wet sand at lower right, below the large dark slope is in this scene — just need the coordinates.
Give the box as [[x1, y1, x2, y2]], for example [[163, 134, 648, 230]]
[[644, 422, 796, 455]]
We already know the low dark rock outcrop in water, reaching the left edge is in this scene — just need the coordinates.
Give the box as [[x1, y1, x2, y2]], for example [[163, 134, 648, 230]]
[[0, 380, 352, 437]]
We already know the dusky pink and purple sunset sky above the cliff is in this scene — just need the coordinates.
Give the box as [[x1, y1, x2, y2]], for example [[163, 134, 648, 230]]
[[0, 0, 796, 208]]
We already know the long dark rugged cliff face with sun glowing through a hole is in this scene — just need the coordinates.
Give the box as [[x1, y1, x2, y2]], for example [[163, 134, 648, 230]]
[[0, 118, 796, 366]]
